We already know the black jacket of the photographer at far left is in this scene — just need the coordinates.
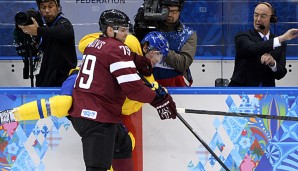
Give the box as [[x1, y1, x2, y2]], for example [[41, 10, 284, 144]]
[[36, 15, 77, 87]]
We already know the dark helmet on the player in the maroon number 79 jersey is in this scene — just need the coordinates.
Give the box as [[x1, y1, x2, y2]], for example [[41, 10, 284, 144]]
[[98, 9, 131, 33]]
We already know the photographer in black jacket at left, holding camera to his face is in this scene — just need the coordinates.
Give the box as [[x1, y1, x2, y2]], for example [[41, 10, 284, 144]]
[[18, 0, 77, 87]]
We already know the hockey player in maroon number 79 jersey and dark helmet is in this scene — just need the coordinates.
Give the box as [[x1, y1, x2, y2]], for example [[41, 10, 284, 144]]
[[69, 9, 177, 171]]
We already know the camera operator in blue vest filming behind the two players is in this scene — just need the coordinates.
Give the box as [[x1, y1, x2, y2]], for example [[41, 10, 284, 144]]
[[135, 0, 197, 87]]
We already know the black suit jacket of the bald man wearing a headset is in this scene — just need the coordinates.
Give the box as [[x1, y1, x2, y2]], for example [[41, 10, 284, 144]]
[[231, 29, 287, 87]]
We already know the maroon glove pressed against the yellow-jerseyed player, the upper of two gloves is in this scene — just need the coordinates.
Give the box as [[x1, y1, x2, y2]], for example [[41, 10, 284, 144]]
[[132, 53, 152, 76]]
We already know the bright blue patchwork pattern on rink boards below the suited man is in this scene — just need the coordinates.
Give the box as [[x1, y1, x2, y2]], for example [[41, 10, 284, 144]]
[[187, 94, 298, 171]]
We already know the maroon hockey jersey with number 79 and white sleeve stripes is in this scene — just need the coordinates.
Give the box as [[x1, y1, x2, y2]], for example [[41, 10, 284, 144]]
[[69, 37, 155, 123]]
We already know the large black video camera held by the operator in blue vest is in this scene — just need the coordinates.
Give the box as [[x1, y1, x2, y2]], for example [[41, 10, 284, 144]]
[[134, 0, 169, 41]]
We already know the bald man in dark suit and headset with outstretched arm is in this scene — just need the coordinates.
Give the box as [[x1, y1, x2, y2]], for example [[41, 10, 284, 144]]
[[229, 2, 298, 87]]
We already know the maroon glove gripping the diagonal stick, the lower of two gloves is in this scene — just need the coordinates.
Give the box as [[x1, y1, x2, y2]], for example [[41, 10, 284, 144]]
[[150, 93, 177, 120]]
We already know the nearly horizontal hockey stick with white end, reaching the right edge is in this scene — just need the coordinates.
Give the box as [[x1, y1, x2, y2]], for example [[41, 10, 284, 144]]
[[177, 108, 298, 121]]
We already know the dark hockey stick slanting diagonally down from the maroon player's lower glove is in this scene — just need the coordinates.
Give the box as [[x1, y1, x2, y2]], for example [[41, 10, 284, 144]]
[[138, 73, 230, 171]]
